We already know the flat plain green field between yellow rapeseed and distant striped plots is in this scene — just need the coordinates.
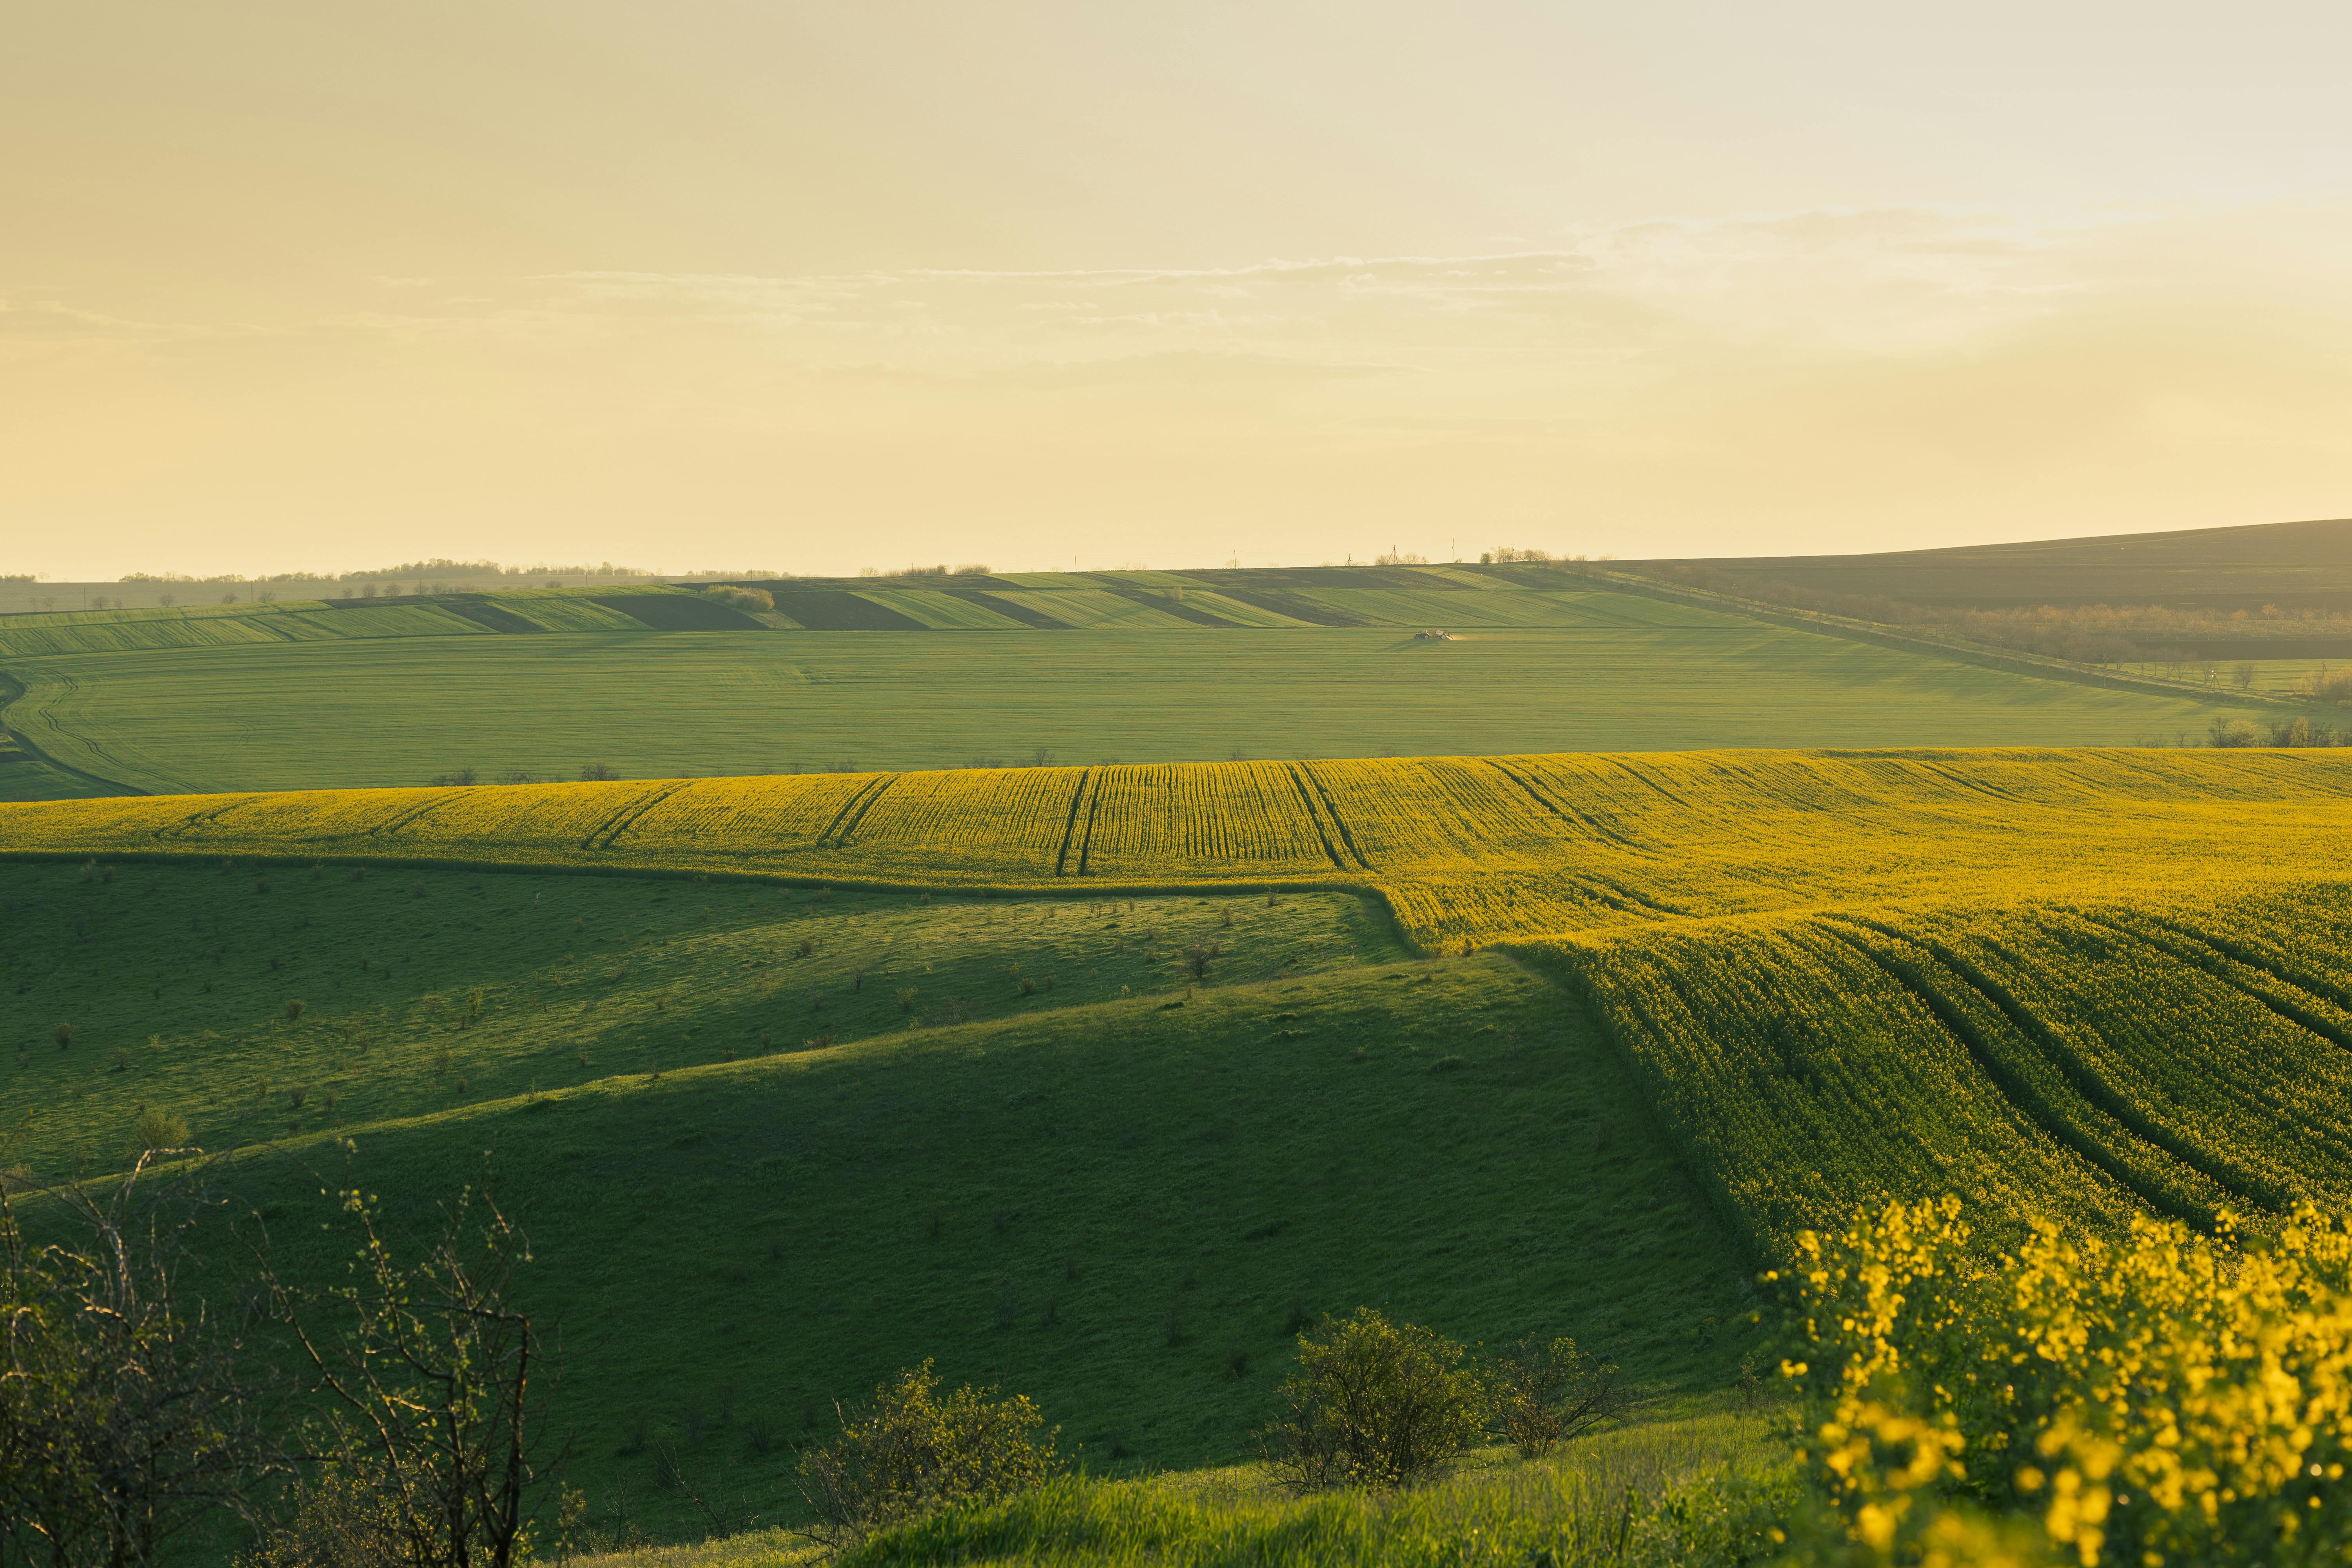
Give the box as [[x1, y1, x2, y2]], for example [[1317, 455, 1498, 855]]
[[5, 625, 2267, 792]]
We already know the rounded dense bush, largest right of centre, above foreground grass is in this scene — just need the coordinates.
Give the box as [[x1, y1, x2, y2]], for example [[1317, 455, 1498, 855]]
[[1265, 1307, 1486, 1493]]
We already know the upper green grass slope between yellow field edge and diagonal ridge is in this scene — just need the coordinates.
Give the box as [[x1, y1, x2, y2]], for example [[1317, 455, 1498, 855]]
[[0, 860, 1406, 1178]]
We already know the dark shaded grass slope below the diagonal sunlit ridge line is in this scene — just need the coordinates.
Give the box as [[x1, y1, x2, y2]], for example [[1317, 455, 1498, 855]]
[[198, 957, 1752, 1533]]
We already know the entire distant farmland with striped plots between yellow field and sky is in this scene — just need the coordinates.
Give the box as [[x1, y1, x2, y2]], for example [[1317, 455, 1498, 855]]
[[0, 545, 2352, 799]]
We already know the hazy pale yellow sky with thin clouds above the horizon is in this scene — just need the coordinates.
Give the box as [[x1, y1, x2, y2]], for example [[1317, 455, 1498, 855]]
[[0, 0, 2352, 578]]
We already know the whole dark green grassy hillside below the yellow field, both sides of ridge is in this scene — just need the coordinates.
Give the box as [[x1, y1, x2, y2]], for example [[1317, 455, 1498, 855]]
[[0, 865, 1752, 1533]]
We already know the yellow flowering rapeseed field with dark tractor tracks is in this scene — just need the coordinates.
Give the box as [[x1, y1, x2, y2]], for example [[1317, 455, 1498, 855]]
[[0, 750, 2352, 1250]]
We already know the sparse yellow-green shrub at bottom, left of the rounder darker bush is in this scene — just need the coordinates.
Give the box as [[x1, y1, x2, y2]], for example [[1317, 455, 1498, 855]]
[[800, 1361, 1061, 1552]]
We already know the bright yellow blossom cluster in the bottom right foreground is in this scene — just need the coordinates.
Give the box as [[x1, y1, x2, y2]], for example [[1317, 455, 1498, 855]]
[[1783, 1199, 2352, 1568]]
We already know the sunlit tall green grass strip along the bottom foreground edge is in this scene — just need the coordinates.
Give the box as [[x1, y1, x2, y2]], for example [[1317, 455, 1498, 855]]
[[576, 1413, 1799, 1568]]
